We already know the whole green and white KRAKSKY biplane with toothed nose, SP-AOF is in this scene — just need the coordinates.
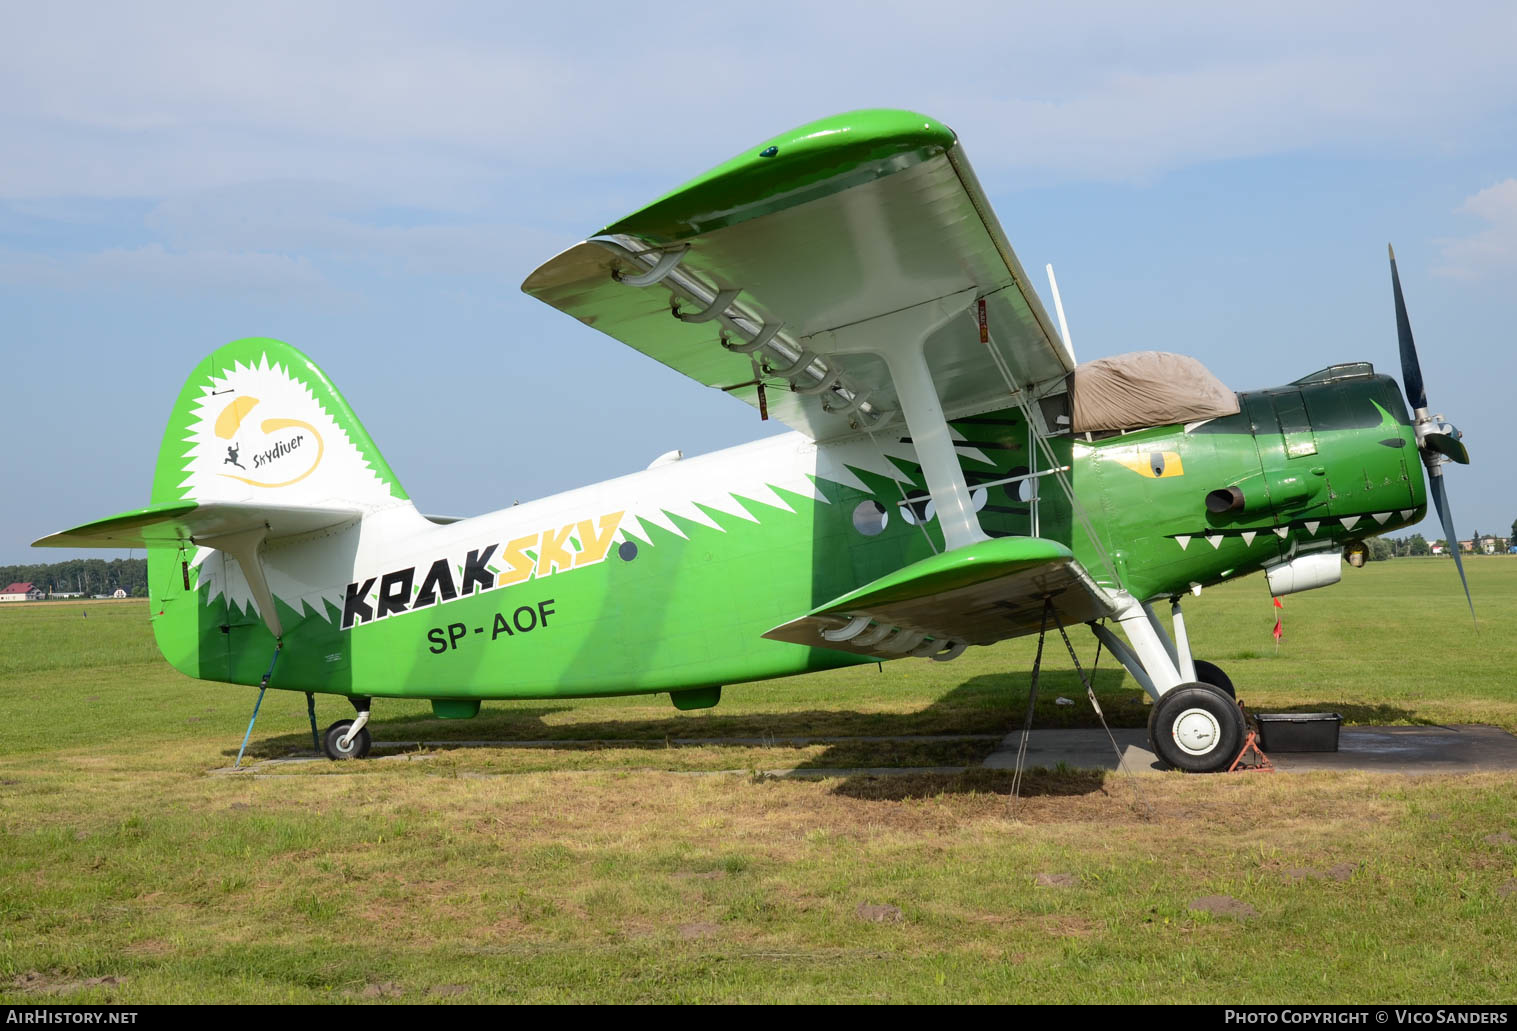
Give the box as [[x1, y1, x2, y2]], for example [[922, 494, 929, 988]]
[[36, 111, 1468, 770]]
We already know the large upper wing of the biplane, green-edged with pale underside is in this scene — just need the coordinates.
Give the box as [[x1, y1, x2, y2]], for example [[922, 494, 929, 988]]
[[522, 111, 1074, 440]]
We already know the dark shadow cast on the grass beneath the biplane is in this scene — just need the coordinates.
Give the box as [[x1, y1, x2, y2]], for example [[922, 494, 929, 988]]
[[223, 669, 1438, 801]]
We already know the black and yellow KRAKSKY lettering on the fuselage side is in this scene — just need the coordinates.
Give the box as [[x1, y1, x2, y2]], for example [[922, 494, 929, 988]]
[[341, 512, 622, 631]]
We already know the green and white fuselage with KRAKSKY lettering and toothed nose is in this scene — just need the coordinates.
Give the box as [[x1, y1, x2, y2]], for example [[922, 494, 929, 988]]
[[150, 357, 1424, 699]]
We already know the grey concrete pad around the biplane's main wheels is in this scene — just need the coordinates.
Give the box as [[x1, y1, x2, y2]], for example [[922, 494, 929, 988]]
[[985, 723, 1517, 773]]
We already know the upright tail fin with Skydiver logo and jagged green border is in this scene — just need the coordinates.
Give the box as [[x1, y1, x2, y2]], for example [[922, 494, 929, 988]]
[[152, 337, 407, 511]]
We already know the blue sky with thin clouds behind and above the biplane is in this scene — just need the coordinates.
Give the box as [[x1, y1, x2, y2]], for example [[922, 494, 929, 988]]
[[0, 2, 1517, 563]]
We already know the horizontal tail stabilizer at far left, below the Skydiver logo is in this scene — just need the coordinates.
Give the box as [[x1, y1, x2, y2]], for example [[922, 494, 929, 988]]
[[32, 502, 363, 547]]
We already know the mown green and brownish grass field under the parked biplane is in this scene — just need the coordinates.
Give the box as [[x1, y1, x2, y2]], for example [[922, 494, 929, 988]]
[[0, 558, 1517, 1002]]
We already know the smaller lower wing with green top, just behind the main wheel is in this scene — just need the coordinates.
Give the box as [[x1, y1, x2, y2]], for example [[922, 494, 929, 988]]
[[765, 537, 1115, 660]]
